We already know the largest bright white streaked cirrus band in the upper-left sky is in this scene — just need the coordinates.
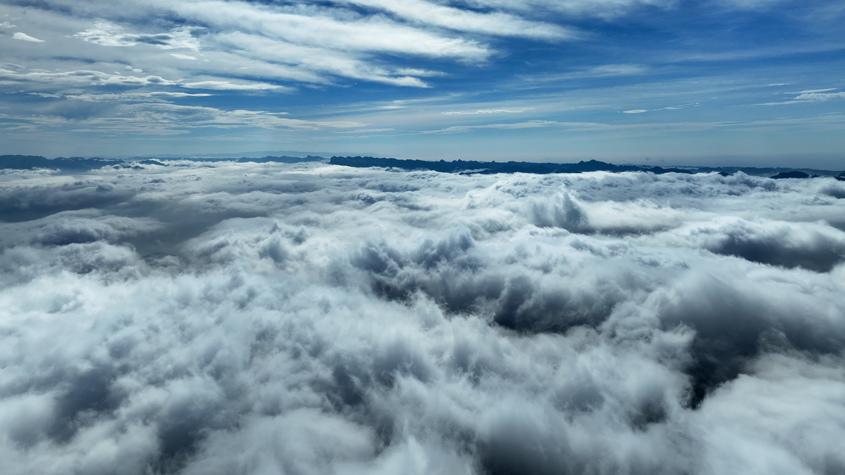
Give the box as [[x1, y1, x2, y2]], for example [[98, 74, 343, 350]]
[[1, 0, 494, 97]]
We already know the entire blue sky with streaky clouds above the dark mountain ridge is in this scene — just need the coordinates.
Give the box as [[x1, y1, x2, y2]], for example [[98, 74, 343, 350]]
[[0, 0, 845, 169]]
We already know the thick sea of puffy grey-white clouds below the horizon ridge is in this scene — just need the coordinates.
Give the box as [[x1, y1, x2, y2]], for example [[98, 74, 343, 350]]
[[0, 161, 845, 474]]
